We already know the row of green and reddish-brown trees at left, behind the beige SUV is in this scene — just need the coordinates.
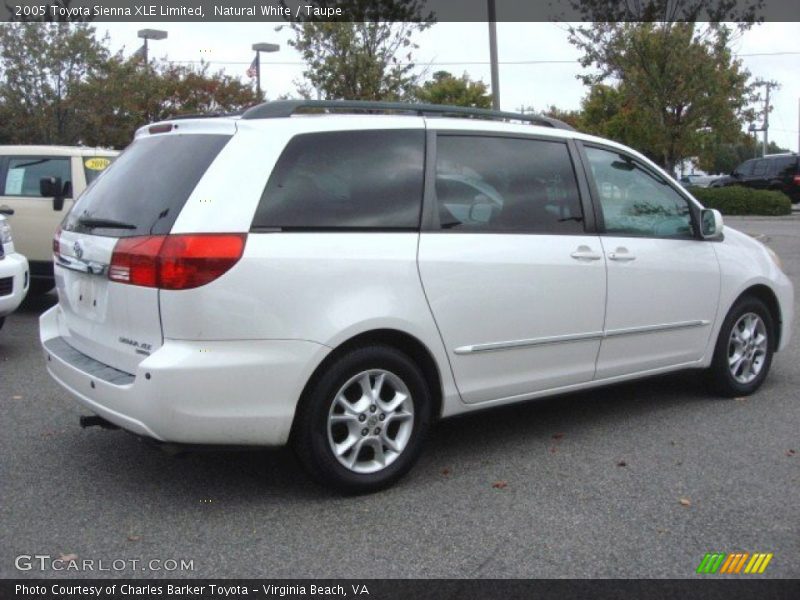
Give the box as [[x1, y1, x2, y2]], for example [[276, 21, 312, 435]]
[[0, 23, 257, 148]]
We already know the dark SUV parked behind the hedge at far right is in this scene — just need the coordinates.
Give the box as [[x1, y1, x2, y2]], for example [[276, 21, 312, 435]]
[[711, 152, 800, 204]]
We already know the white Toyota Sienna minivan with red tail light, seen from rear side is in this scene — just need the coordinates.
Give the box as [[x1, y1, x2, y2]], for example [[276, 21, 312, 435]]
[[40, 101, 794, 492]]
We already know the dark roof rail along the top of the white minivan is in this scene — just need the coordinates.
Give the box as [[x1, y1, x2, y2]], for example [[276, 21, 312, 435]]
[[242, 100, 575, 131]]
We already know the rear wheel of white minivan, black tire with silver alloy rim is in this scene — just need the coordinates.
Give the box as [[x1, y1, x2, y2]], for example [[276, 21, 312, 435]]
[[292, 346, 432, 494]]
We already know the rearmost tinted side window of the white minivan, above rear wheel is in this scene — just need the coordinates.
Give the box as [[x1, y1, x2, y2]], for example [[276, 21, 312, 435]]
[[253, 130, 425, 229]]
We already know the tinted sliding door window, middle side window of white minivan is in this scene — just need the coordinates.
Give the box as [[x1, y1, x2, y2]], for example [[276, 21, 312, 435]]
[[436, 135, 583, 234]]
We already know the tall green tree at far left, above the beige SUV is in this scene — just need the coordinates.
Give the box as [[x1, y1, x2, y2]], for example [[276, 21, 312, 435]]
[[0, 23, 108, 144]]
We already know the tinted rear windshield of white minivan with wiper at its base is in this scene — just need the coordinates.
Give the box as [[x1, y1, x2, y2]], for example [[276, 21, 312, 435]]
[[63, 134, 231, 237]]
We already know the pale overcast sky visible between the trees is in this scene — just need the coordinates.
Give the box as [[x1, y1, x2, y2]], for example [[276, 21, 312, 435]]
[[96, 22, 800, 151]]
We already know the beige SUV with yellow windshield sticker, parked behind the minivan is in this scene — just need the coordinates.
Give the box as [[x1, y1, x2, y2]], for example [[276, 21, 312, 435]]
[[0, 146, 119, 294]]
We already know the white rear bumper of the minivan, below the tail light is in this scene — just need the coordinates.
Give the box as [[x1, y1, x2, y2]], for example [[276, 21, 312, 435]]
[[39, 306, 330, 446]]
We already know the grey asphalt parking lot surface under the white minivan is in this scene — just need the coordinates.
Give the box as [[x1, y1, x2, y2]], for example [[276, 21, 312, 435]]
[[0, 216, 800, 578]]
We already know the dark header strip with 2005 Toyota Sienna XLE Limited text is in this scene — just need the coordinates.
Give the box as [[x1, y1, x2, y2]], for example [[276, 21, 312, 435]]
[[0, 0, 800, 23]]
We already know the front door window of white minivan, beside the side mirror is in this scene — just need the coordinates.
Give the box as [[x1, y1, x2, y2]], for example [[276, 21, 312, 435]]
[[586, 147, 693, 238]]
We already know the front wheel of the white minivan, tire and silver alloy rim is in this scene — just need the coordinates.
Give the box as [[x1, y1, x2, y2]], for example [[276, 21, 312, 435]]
[[708, 297, 775, 397]]
